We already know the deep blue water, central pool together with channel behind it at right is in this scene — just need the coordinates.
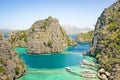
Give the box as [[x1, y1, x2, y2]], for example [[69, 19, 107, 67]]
[[16, 43, 89, 69]]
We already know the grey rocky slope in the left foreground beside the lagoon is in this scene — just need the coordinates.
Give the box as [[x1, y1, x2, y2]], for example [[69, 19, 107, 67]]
[[0, 35, 25, 80]]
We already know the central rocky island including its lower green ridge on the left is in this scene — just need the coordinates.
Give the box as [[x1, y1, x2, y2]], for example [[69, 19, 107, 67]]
[[9, 17, 76, 53]]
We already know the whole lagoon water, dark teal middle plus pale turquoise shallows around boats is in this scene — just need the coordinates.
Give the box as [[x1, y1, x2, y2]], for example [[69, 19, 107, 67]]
[[15, 43, 99, 80]]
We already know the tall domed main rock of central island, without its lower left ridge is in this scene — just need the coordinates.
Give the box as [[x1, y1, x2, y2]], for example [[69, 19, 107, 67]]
[[28, 17, 73, 53]]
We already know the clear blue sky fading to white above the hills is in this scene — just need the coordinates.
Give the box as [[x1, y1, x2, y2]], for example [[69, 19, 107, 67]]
[[0, 0, 116, 30]]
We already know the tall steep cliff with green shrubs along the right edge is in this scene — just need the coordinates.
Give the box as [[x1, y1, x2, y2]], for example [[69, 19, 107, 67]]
[[90, 0, 120, 80]]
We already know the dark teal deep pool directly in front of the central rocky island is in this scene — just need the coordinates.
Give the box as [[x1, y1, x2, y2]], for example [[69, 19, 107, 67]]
[[20, 54, 82, 69]]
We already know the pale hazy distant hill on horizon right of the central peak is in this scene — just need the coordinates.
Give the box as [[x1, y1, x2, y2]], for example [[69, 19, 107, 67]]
[[62, 25, 92, 34]]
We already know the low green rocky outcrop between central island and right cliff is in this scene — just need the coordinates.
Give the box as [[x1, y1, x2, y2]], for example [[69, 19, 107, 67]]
[[76, 31, 93, 42]]
